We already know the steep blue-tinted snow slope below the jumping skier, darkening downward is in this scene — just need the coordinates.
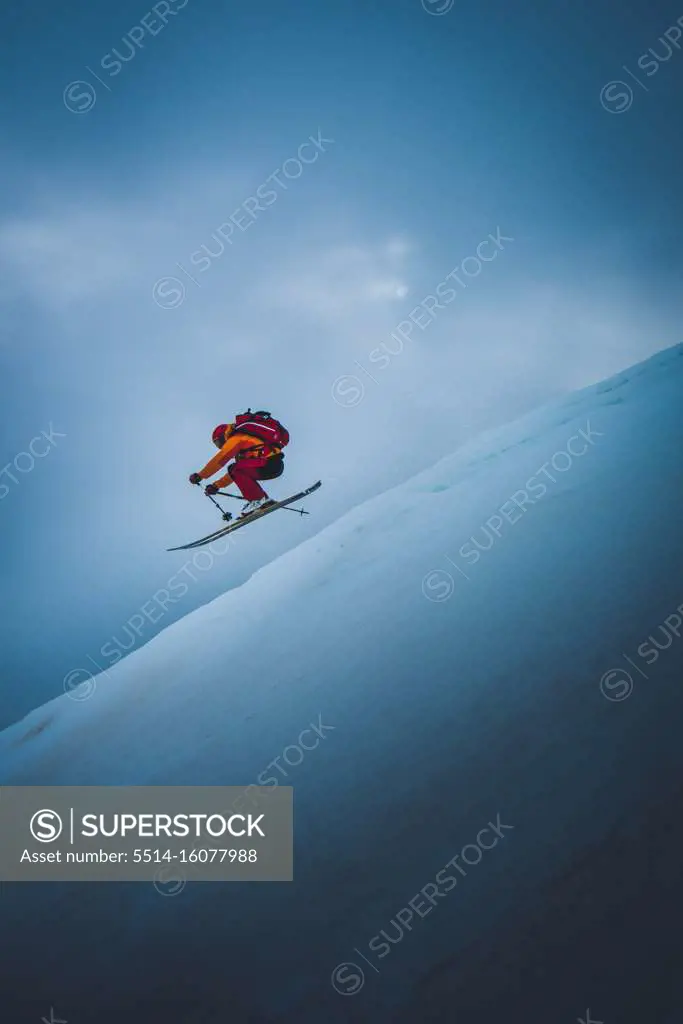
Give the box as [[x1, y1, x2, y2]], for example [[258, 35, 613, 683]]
[[0, 346, 683, 1024]]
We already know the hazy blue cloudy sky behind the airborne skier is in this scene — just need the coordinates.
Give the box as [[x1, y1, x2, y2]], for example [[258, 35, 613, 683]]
[[0, 0, 683, 723]]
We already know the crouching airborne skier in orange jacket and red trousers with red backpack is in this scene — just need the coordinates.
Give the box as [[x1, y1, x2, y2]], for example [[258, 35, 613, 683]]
[[189, 409, 290, 518]]
